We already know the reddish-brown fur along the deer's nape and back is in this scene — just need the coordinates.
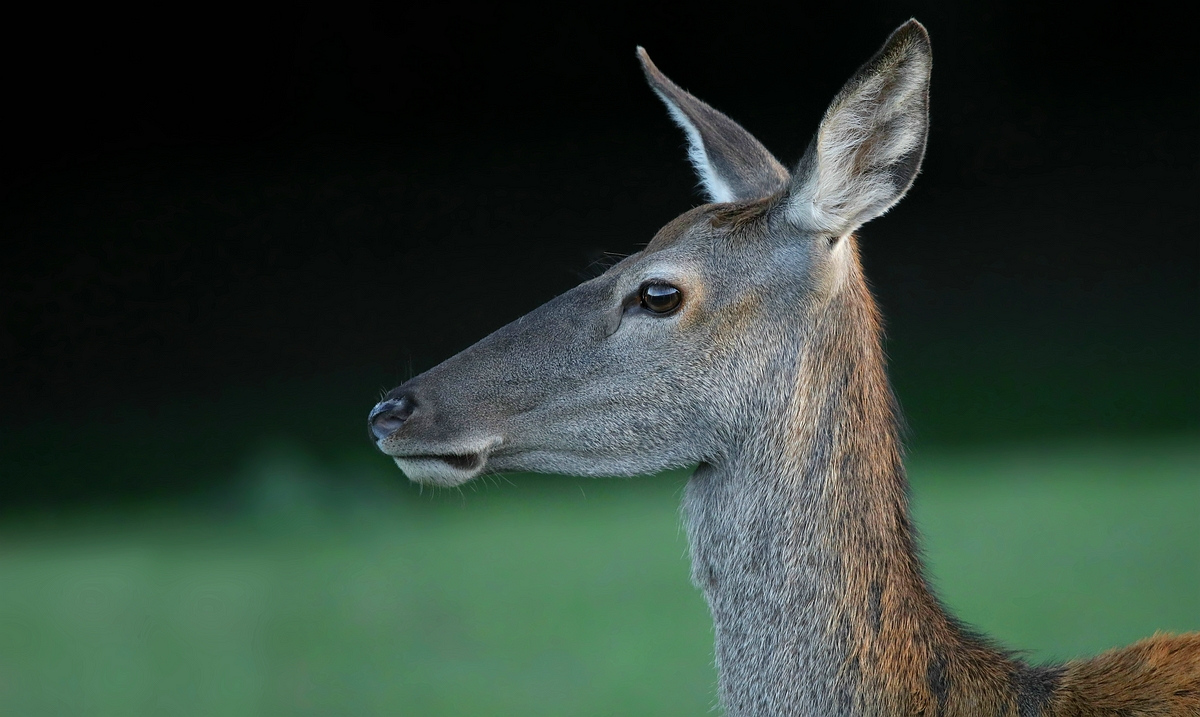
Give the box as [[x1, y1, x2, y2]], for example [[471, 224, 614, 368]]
[[792, 236, 1200, 717]]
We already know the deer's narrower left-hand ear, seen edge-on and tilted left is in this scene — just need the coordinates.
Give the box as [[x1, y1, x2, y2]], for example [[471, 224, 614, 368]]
[[637, 48, 788, 201]]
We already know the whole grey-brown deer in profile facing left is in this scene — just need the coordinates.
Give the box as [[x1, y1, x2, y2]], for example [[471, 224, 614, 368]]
[[368, 20, 1200, 717]]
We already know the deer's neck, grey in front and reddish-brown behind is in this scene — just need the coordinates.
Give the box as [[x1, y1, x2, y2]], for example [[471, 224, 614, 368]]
[[684, 240, 1012, 716]]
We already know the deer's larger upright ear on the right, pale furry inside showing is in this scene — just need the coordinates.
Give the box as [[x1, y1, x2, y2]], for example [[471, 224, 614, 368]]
[[787, 20, 932, 235]]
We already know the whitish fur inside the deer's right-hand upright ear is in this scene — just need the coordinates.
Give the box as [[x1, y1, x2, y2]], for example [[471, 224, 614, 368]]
[[788, 52, 929, 235]]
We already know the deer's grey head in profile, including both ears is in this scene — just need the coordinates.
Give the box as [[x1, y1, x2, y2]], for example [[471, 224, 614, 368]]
[[370, 20, 931, 486]]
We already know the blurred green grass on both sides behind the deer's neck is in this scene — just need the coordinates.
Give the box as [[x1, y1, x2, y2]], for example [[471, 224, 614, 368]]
[[0, 435, 1200, 717]]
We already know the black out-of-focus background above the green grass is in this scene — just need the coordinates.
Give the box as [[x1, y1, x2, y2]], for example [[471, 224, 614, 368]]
[[0, 2, 1200, 510]]
